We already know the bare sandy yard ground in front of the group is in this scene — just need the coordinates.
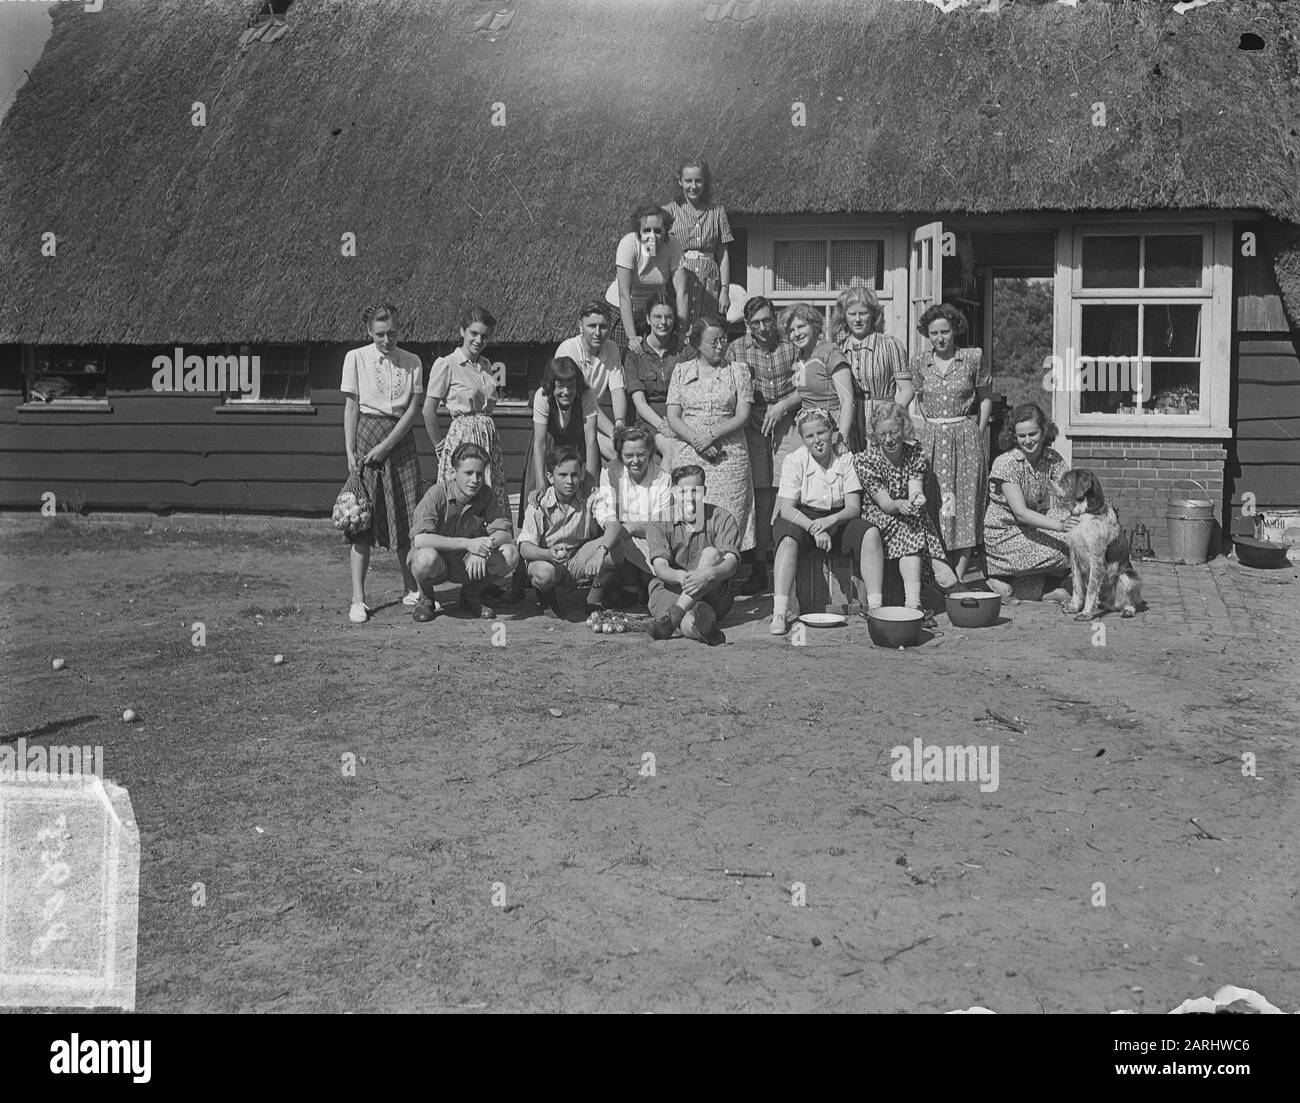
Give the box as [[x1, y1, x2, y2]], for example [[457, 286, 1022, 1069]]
[[0, 520, 1300, 1012]]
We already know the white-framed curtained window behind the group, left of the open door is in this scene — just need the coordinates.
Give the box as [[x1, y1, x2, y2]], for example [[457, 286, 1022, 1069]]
[[748, 224, 906, 331]]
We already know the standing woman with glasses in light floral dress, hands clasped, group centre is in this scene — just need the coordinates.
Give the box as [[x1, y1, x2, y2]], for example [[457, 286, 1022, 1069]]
[[668, 315, 754, 552]]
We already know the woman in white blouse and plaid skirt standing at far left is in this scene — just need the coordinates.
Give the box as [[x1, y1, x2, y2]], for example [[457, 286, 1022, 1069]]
[[339, 303, 424, 624]]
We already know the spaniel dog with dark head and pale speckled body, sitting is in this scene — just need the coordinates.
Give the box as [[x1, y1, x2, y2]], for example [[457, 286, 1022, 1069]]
[[1056, 468, 1143, 620]]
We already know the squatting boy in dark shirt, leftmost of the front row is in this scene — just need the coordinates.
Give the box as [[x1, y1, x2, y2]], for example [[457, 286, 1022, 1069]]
[[407, 441, 519, 623]]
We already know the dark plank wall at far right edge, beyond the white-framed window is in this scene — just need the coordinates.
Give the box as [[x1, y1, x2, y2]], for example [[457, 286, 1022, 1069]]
[[1225, 222, 1300, 533]]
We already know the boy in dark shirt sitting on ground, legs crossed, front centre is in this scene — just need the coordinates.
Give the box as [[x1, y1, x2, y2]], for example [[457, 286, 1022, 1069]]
[[646, 464, 740, 645]]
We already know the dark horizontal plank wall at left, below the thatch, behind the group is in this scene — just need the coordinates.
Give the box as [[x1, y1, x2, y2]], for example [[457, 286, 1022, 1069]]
[[0, 345, 532, 514]]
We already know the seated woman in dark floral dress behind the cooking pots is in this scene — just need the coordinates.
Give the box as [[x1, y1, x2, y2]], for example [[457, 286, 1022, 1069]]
[[854, 403, 957, 627]]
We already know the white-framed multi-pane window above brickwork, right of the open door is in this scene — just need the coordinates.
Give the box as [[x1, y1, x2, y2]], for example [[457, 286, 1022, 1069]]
[[1056, 224, 1231, 431]]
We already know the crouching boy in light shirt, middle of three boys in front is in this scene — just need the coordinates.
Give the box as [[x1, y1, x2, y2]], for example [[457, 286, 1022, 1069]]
[[519, 445, 623, 618]]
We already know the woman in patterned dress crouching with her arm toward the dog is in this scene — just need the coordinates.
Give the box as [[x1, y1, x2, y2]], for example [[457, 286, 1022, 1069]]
[[984, 402, 1078, 601]]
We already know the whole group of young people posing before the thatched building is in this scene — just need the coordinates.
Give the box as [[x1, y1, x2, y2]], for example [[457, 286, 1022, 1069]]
[[342, 154, 1073, 644]]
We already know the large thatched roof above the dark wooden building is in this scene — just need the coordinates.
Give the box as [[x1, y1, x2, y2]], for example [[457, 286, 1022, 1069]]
[[0, 0, 1300, 343]]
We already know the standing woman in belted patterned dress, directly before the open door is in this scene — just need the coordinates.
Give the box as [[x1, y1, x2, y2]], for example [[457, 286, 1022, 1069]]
[[911, 303, 993, 579]]
